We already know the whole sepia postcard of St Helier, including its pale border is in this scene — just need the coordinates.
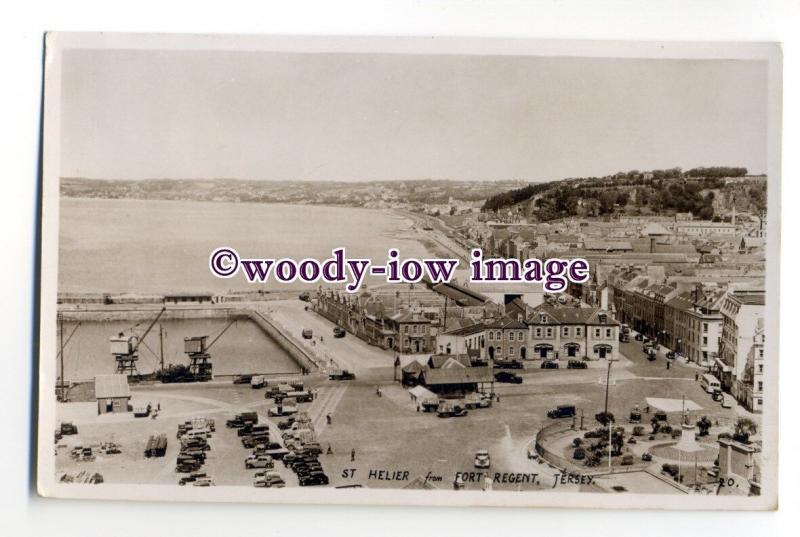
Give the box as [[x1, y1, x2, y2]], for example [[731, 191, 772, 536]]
[[36, 33, 782, 510]]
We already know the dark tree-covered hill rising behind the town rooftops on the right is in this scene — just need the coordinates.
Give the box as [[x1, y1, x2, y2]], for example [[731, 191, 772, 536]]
[[482, 166, 767, 221]]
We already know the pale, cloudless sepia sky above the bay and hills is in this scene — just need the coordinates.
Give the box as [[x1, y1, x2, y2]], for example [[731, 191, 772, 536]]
[[56, 50, 767, 182]]
